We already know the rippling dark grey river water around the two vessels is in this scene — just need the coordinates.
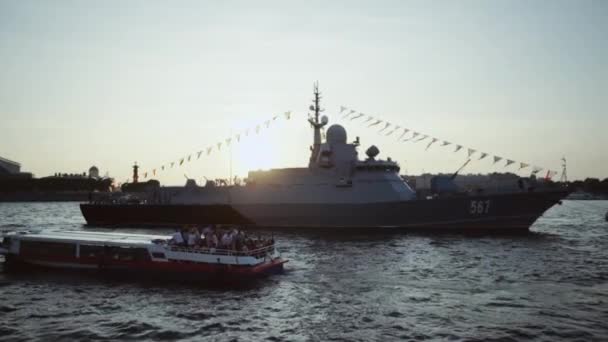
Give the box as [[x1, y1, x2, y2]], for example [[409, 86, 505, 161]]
[[0, 201, 608, 341]]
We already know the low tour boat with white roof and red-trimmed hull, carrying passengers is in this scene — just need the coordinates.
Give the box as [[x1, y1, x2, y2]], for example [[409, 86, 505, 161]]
[[0, 231, 287, 279]]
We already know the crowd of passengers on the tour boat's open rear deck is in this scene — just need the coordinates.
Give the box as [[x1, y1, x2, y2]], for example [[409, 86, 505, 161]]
[[169, 226, 274, 252]]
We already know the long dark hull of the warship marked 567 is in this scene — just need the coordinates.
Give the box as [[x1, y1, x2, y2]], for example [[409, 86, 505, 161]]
[[80, 191, 568, 232]]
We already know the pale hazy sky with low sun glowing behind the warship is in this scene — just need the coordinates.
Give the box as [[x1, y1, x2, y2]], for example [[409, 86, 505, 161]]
[[0, 0, 608, 184]]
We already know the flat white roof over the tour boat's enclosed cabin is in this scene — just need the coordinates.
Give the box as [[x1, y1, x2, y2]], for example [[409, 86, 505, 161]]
[[5, 230, 170, 245]]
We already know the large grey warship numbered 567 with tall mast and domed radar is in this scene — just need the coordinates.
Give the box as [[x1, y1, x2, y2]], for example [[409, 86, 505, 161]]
[[80, 85, 569, 232]]
